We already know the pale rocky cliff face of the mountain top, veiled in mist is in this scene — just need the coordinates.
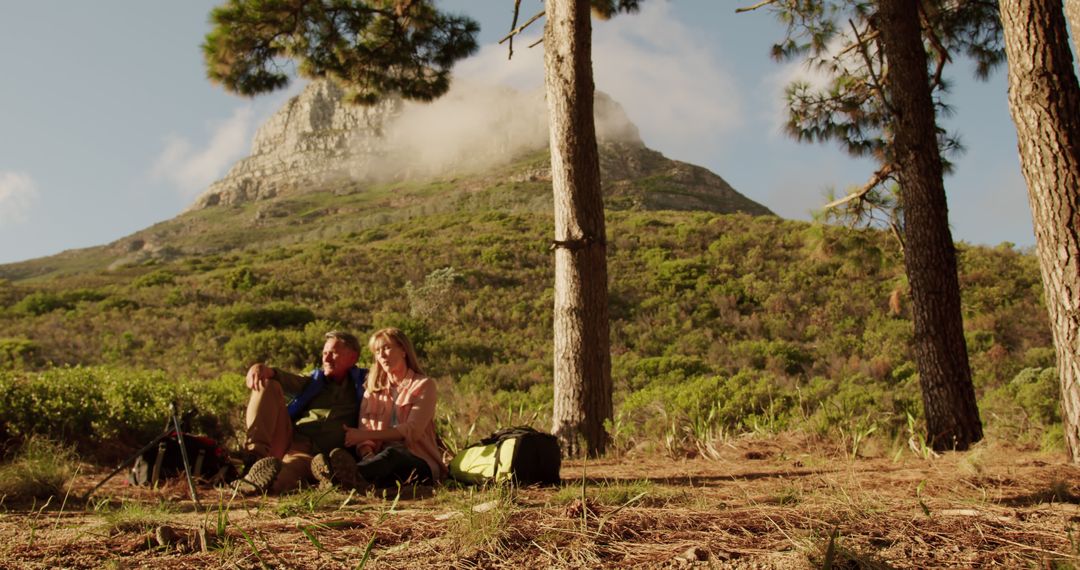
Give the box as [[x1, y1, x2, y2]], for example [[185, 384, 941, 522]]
[[190, 81, 644, 209]]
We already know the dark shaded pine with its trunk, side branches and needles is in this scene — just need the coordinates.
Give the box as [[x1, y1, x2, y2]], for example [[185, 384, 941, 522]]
[[766, 0, 1002, 450]]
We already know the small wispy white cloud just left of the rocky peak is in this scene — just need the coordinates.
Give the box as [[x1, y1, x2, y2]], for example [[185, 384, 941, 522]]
[[150, 105, 255, 198]]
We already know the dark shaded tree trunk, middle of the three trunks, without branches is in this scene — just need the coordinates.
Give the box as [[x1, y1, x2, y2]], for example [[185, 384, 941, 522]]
[[878, 0, 983, 450]]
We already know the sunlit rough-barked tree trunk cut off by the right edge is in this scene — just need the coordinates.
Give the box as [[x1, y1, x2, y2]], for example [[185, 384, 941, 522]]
[[1001, 0, 1080, 464]]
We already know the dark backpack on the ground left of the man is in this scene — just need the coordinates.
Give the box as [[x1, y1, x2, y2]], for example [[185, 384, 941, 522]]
[[127, 431, 237, 485]]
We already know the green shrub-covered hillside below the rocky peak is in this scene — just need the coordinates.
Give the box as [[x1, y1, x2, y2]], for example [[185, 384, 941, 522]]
[[0, 148, 1059, 453]]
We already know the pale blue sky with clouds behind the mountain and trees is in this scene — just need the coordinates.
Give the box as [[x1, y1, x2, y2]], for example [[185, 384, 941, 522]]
[[0, 0, 1034, 262]]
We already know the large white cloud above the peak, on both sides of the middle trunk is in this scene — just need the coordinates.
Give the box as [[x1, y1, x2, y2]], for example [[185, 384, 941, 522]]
[[455, 2, 742, 162]]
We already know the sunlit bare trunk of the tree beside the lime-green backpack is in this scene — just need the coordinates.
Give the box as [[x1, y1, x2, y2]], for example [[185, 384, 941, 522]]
[[543, 0, 611, 456]]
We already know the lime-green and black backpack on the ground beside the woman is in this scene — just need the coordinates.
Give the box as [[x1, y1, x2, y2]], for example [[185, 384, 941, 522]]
[[450, 426, 563, 485]]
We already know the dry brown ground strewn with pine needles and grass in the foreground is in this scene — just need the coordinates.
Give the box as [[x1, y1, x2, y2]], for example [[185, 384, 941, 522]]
[[0, 436, 1080, 570]]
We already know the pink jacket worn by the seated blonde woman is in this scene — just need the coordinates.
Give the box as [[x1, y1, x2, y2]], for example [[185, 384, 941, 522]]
[[357, 377, 447, 480]]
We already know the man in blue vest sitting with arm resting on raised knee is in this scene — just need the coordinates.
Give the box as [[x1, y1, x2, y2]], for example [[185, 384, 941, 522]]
[[237, 330, 367, 493]]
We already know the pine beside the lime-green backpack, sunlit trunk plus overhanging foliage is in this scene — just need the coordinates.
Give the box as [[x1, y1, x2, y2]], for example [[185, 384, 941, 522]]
[[203, 0, 640, 456]]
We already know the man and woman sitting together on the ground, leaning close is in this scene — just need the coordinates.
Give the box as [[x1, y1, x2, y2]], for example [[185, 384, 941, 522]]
[[237, 328, 446, 493]]
